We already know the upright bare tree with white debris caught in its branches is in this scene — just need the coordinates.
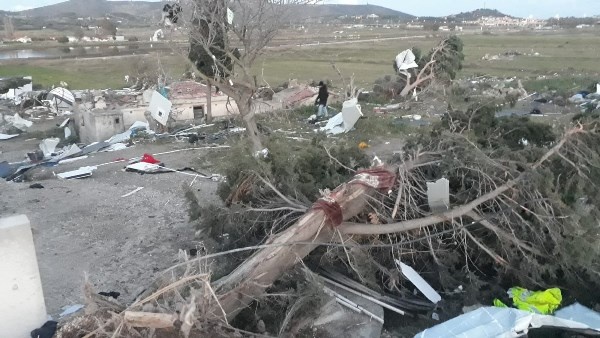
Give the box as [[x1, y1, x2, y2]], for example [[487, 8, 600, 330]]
[[181, 0, 316, 151]]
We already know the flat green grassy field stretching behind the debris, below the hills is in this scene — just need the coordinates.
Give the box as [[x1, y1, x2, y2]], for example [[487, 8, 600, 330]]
[[0, 28, 600, 90]]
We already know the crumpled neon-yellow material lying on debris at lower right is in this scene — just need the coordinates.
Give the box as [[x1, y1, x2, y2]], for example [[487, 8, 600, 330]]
[[506, 287, 562, 315]]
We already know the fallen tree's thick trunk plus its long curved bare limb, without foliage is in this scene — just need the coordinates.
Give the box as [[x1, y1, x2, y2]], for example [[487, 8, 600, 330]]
[[207, 127, 584, 319]]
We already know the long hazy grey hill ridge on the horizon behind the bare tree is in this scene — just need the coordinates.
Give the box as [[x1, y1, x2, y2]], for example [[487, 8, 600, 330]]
[[17, 0, 413, 19]]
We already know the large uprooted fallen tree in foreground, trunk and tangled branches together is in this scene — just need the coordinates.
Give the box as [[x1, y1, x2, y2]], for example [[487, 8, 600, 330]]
[[62, 115, 600, 333]]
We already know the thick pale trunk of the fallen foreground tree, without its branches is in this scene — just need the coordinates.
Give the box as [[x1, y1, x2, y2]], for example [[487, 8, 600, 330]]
[[213, 184, 375, 320]]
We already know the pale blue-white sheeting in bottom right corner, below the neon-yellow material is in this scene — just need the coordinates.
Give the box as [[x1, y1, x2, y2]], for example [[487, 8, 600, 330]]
[[415, 305, 600, 338]]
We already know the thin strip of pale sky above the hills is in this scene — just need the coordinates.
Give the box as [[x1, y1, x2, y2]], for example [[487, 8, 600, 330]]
[[0, 0, 600, 18]]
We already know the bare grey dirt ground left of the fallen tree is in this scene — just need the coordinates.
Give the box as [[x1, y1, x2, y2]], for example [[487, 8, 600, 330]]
[[0, 135, 226, 318]]
